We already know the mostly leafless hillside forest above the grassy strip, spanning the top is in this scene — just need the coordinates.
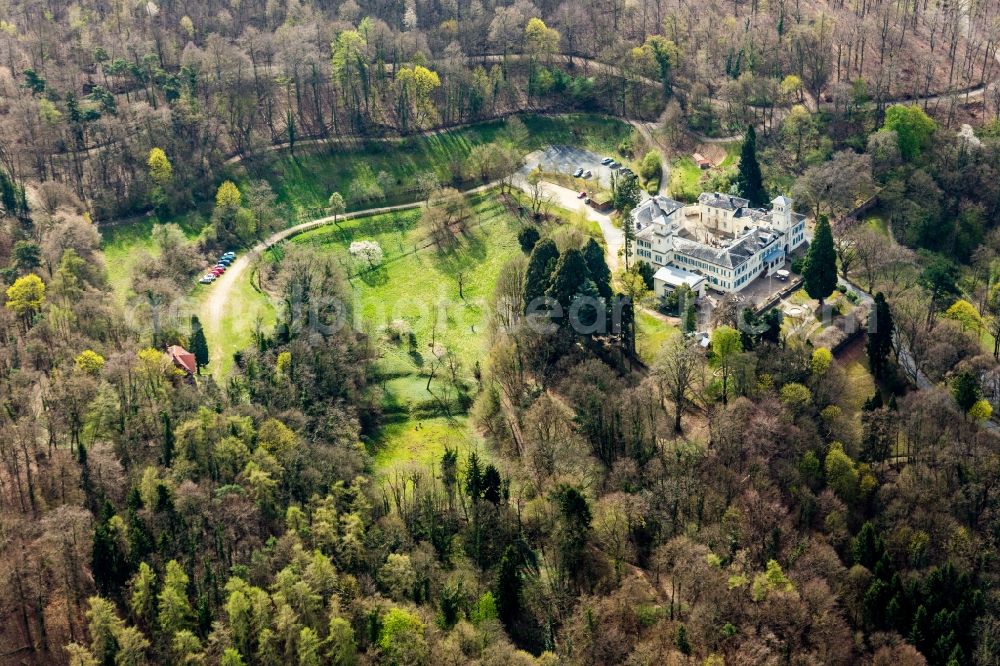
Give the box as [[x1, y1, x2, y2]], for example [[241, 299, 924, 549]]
[[0, 0, 1000, 222]]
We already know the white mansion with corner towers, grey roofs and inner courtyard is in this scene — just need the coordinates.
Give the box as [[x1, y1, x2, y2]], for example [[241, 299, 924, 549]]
[[630, 192, 806, 296]]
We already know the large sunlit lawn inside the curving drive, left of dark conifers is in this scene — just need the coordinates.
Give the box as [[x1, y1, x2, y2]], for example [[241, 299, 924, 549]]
[[291, 193, 521, 473]]
